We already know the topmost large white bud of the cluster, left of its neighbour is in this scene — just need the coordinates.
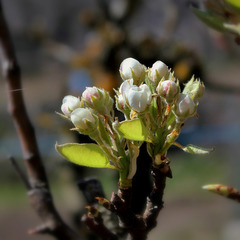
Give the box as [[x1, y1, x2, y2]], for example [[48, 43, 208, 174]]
[[119, 58, 145, 85]]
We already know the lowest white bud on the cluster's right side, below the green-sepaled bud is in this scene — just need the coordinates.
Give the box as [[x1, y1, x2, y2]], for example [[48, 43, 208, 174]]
[[174, 93, 197, 122]]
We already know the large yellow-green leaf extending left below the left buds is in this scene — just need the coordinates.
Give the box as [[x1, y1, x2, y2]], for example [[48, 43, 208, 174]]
[[55, 143, 114, 168]]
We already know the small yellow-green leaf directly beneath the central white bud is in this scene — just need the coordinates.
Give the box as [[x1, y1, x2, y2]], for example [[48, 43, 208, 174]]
[[116, 118, 151, 142]]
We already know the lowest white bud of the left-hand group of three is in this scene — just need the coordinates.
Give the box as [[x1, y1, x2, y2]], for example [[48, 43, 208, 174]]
[[71, 108, 97, 134]]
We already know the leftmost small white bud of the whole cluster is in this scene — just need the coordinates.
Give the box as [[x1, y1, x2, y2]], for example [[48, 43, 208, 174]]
[[61, 95, 81, 117]]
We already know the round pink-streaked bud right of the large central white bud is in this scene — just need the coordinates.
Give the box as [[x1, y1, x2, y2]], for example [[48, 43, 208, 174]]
[[156, 80, 180, 104]]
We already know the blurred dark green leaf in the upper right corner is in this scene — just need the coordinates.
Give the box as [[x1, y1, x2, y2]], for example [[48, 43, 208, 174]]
[[193, 8, 225, 32]]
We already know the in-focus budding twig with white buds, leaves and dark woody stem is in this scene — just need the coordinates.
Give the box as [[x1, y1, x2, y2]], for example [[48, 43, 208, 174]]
[[56, 55, 211, 240]]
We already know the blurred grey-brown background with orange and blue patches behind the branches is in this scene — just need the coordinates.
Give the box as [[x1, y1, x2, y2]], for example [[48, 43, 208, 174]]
[[0, 0, 240, 240]]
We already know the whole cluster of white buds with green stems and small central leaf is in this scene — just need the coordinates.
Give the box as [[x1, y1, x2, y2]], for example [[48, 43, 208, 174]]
[[58, 58, 204, 186]]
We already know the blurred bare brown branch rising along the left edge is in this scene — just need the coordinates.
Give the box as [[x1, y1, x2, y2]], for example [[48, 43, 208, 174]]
[[0, 2, 80, 240]]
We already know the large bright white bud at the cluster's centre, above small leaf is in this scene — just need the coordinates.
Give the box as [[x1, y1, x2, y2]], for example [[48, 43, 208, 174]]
[[126, 84, 152, 112]]
